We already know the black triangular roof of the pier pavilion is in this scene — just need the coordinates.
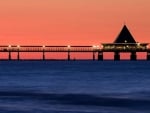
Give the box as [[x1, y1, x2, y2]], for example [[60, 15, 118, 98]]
[[114, 25, 136, 43]]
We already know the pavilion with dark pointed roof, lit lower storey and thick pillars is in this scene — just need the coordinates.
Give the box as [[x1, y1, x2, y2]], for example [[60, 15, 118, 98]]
[[102, 25, 148, 60]]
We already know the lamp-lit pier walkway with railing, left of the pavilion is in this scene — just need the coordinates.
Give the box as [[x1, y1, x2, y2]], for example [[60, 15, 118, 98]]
[[0, 46, 97, 52]]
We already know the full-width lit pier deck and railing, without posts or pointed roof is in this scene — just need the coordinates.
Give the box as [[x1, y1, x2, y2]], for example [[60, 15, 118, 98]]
[[0, 43, 150, 52]]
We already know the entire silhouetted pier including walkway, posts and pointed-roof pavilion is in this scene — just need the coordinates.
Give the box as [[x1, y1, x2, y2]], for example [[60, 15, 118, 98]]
[[0, 25, 150, 61]]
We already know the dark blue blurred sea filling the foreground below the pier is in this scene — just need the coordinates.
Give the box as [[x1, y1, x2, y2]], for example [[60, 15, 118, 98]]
[[0, 61, 150, 113]]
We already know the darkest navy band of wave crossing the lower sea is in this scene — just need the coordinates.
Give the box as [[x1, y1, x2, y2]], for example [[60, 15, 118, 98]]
[[0, 91, 150, 110]]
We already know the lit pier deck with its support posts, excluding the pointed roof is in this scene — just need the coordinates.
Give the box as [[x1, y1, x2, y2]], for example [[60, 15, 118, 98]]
[[0, 43, 150, 61]]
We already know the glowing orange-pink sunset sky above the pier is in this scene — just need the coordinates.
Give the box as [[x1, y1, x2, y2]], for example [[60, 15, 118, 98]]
[[0, 0, 150, 45]]
